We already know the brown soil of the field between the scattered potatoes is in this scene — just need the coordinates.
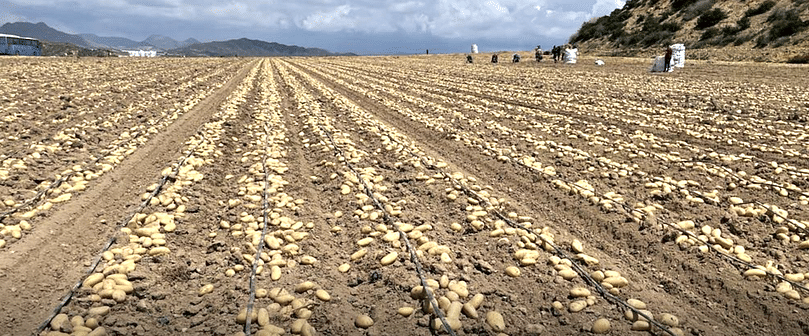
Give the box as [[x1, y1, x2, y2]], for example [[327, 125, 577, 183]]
[[0, 55, 809, 335]]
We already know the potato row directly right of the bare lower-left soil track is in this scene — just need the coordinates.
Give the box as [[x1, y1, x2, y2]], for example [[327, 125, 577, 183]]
[[42, 60, 256, 336]]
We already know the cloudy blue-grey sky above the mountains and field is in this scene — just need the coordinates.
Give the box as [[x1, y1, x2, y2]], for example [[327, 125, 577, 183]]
[[0, 0, 625, 54]]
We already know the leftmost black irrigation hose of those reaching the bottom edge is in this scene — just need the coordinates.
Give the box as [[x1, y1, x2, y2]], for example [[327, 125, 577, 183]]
[[33, 134, 205, 336]]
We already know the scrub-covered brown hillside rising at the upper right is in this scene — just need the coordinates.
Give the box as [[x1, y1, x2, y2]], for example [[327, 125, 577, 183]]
[[570, 0, 809, 58]]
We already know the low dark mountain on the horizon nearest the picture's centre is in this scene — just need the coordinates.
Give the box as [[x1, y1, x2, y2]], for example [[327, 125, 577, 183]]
[[167, 38, 354, 56]]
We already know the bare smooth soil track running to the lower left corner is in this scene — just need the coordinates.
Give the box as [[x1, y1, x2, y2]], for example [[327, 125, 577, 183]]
[[0, 62, 256, 335]]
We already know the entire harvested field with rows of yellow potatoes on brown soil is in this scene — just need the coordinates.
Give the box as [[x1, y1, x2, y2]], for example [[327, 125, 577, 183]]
[[0, 55, 809, 336]]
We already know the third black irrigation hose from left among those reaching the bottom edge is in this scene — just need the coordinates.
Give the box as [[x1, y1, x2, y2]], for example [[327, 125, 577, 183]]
[[318, 125, 456, 336]]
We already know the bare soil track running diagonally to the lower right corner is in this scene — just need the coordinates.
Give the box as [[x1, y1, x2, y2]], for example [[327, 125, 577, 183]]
[[284, 59, 802, 335]]
